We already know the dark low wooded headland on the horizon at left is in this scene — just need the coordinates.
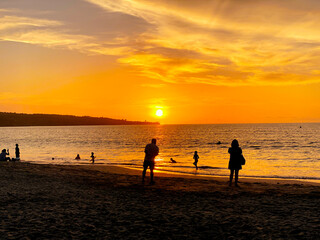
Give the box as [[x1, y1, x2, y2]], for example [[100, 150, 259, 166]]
[[0, 112, 159, 127]]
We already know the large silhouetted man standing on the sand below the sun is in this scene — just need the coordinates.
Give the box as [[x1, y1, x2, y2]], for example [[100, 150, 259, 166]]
[[142, 138, 159, 184]]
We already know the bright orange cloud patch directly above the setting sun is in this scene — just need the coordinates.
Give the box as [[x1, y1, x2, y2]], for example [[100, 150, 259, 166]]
[[119, 53, 250, 85]]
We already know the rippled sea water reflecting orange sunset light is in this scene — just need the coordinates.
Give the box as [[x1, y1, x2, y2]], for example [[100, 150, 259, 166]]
[[0, 123, 320, 181]]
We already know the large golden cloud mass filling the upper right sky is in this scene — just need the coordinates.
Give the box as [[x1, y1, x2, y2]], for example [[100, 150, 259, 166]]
[[87, 0, 320, 86]]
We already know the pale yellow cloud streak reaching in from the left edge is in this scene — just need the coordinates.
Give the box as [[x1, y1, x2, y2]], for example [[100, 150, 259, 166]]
[[0, 13, 134, 56]]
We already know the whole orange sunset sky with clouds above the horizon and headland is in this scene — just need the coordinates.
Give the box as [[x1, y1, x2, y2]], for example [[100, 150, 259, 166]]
[[0, 0, 320, 123]]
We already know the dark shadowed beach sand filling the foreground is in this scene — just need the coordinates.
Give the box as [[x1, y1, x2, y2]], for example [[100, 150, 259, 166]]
[[0, 162, 320, 239]]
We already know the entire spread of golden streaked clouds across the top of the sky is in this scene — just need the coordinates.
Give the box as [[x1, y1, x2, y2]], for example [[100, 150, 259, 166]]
[[0, 0, 320, 86]]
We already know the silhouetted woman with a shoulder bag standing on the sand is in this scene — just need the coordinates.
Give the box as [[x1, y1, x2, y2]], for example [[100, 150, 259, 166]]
[[228, 139, 242, 186]]
